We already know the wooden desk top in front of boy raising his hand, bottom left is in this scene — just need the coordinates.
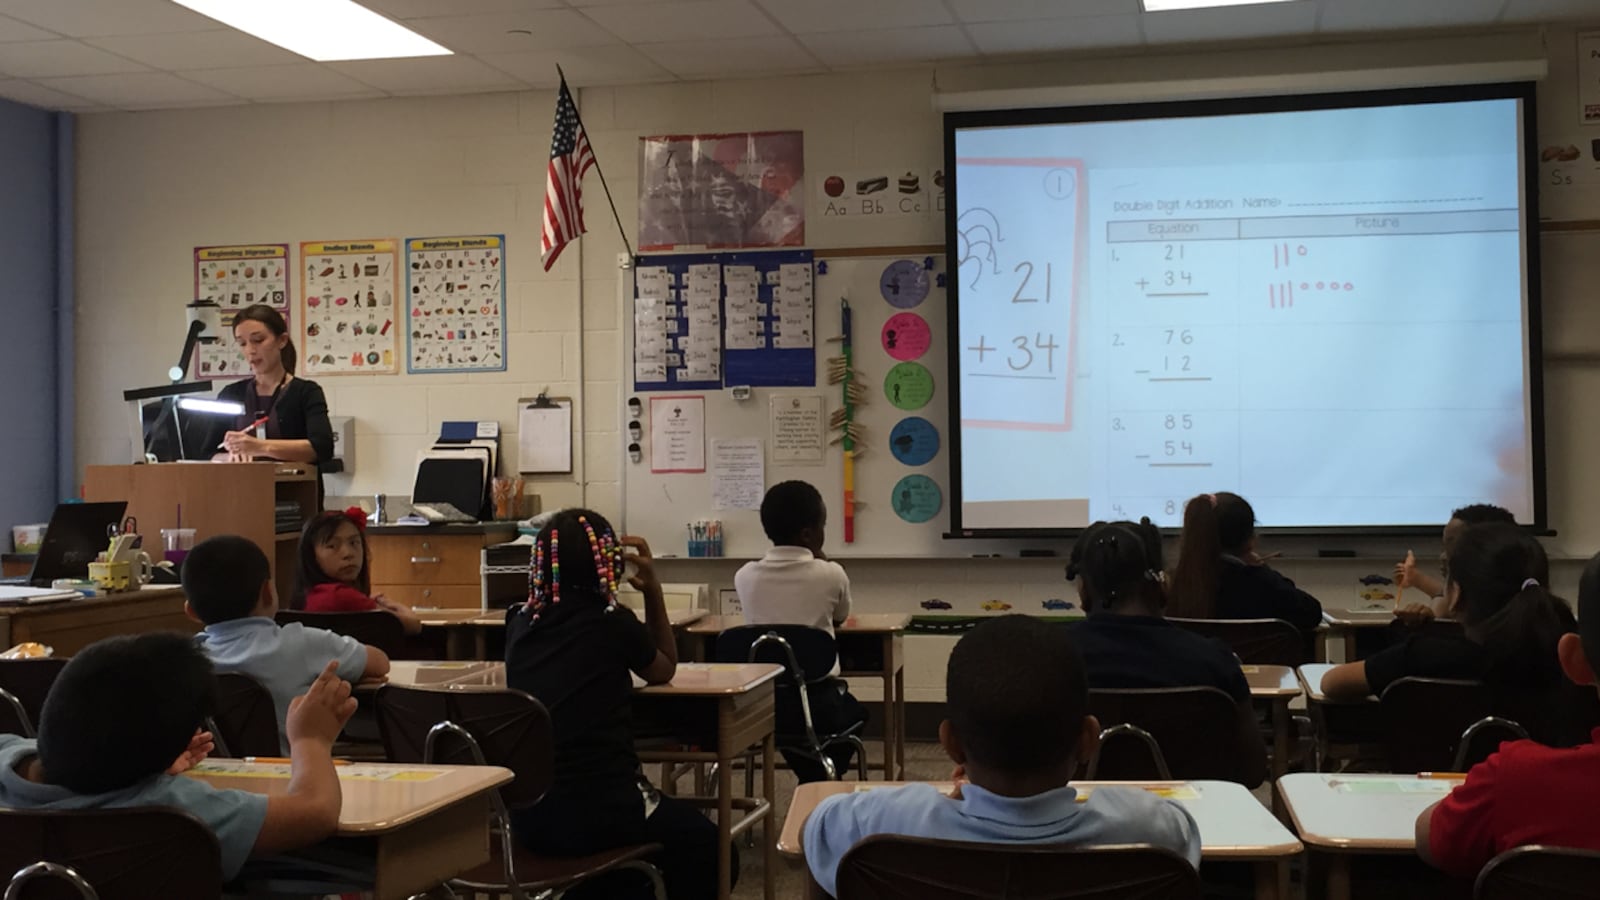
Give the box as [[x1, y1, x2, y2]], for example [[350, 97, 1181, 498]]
[[186, 759, 512, 838]]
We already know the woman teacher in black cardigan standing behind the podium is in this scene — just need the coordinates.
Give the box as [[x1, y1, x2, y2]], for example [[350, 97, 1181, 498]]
[[218, 303, 333, 493]]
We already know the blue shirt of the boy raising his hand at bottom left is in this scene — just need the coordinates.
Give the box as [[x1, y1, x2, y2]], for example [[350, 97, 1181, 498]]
[[0, 735, 267, 881]]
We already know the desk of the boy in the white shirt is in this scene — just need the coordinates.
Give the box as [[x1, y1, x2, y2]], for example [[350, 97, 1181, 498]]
[[688, 613, 910, 781]]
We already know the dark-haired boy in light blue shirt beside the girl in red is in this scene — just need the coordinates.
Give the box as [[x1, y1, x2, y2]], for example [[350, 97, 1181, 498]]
[[182, 535, 389, 751]]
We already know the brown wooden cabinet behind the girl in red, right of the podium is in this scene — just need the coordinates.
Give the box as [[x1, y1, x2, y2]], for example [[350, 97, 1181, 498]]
[[366, 524, 517, 609]]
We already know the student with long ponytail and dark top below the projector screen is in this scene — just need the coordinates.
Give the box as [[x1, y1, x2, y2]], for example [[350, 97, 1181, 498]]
[[1166, 490, 1322, 634]]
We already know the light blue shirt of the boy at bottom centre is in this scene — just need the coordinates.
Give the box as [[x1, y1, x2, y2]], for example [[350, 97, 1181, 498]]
[[802, 775, 1200, 895]]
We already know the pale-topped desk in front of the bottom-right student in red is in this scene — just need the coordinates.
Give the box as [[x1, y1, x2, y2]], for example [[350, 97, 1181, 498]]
[[1278, 772, 1461, 900]]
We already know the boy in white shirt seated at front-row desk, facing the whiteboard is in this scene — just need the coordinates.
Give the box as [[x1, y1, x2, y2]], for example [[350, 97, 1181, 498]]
[[733, 480, 867, 783]]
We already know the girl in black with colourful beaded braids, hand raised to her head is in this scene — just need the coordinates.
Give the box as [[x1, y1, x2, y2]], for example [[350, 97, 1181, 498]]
[[506, 509, 739, 900]]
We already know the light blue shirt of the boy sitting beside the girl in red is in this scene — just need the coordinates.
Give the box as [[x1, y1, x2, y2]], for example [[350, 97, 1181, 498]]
[[195, 615, 366, 754]]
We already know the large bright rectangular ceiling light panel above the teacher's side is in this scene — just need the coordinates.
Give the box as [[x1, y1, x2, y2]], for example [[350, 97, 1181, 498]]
[[173, 0, 451, 62]]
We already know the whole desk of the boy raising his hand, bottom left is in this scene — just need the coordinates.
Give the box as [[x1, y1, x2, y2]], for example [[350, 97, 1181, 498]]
[[186, 759, 512, 900]]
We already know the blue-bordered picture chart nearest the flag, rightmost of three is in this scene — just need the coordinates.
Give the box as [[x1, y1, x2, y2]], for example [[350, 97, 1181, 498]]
[[405, 234, 506, 375]]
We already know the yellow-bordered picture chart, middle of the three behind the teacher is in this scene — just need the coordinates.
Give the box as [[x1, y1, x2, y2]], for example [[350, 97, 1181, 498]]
[[299, 237, 402, 375]]
